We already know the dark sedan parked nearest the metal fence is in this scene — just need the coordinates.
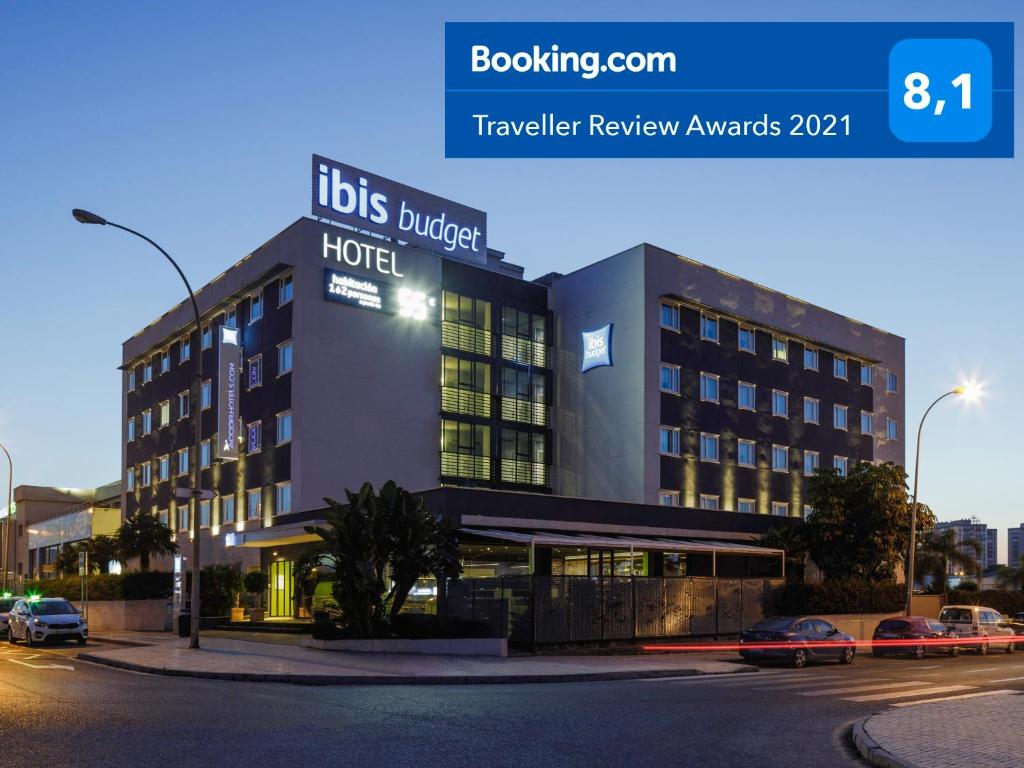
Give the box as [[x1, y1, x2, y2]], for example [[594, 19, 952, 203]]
[[739, 616, 857, 668]]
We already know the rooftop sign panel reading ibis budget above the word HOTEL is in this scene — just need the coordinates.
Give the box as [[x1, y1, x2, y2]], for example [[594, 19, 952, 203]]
[[312, 155, 487, 263]]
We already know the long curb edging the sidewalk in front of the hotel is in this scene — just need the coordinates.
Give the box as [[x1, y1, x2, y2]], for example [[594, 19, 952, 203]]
[[78, 653, 757, 685]]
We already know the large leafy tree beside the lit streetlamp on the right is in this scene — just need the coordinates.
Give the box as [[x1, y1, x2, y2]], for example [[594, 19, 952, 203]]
[[802, 462, 935, 582]]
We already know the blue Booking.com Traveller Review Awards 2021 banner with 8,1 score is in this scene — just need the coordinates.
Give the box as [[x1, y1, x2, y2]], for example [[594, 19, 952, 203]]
[[444, 23, 1014, 158]]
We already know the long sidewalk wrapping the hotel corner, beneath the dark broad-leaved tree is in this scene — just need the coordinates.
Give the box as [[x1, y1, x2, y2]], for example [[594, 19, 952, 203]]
[[79, 633, 756, 685]]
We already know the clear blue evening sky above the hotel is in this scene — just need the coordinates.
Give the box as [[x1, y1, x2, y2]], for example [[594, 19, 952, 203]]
[[0, 0, 1024, 549]]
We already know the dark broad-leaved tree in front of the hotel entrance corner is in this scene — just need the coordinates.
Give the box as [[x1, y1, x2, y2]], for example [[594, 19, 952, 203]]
[[296, 480, 462, 637]]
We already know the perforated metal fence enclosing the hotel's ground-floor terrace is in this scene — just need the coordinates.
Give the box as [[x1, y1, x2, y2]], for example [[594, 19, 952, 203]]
[[447, 575, 783, 646]]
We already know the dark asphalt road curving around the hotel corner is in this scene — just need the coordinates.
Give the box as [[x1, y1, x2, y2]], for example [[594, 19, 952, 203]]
[[0, 643, 1024, 768]]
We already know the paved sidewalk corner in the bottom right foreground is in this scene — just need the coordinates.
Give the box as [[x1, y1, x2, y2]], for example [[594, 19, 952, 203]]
[[853, 691, 1024, 768]]
